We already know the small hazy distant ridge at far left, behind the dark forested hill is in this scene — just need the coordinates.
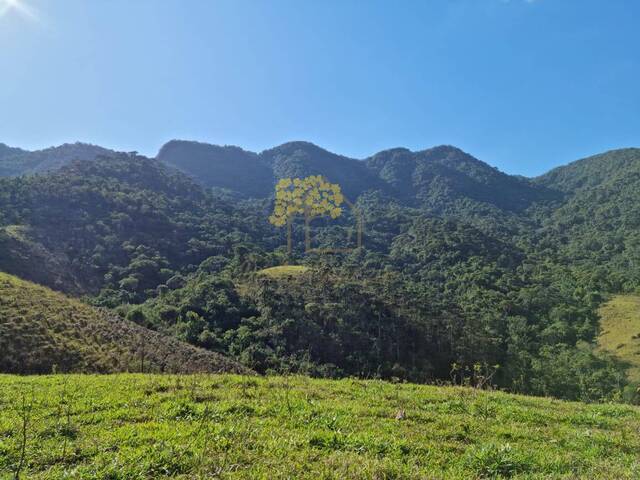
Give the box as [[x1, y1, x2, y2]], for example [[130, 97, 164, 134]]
[[0, 143, 115, 177]]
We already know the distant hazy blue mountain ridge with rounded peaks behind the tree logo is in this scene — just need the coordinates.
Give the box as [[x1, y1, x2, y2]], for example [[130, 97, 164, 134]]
[[157, 140, 554, 211]]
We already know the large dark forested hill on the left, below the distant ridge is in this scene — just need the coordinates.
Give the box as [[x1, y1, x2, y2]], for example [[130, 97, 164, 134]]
[[0, 154, 269, 296]]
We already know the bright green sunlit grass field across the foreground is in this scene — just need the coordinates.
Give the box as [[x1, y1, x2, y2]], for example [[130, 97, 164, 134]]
[[0, 374, 640, 479]]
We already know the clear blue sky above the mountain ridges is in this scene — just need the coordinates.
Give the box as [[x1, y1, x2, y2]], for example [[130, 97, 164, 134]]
[[0, 0, 640, 175]]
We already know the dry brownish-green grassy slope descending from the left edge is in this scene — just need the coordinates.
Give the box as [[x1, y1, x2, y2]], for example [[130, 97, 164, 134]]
[[0, 273, 251, 373]]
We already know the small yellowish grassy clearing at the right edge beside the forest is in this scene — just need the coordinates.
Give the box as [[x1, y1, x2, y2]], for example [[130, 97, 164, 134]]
[[598, 295, 640, 383]]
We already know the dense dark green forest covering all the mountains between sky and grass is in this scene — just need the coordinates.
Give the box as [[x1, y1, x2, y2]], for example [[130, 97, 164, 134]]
[[0, 141, 640, 401]]
